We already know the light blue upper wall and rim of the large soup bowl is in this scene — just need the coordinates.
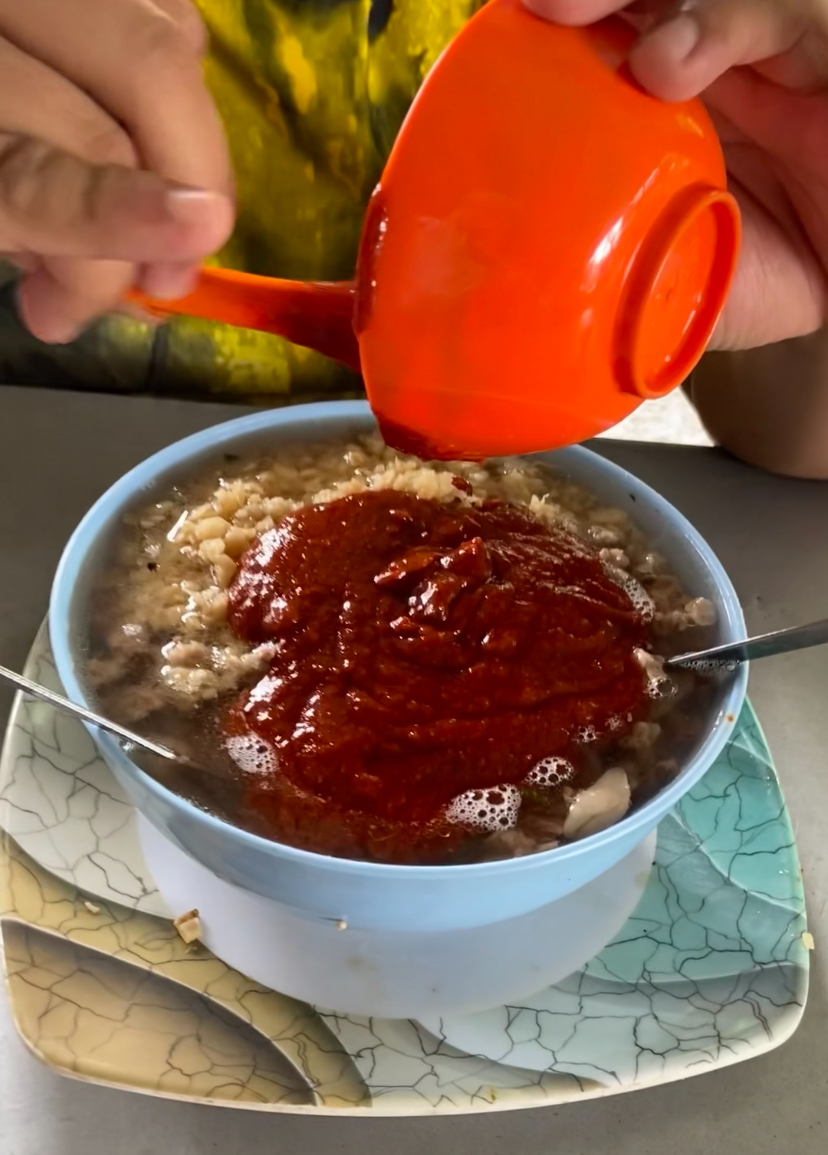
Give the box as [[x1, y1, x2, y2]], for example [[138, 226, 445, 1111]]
[[50, 402, 747, 931]]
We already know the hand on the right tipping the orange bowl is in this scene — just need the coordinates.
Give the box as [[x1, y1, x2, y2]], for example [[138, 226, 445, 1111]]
[[524, 0, 828, 350]]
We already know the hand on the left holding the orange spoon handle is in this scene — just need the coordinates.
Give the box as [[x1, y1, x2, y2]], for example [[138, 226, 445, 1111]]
[[0, 0, 233, 342]]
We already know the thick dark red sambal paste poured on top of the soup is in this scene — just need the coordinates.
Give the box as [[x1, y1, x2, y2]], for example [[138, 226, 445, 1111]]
[[227, 490, 648, 860]]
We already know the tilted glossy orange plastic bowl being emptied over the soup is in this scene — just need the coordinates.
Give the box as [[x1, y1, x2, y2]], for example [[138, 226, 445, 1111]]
[[356, 0, 740, 457]]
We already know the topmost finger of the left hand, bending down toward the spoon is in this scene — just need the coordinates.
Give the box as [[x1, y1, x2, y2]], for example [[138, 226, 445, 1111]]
[[0, 0, 231, 191]]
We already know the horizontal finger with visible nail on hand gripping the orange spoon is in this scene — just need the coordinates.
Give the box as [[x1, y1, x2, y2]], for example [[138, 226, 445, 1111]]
[[0, 134, 233, 263]]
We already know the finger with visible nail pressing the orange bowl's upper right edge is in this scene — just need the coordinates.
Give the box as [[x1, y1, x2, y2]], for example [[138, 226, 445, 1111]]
[[629, 0, 807, 100]]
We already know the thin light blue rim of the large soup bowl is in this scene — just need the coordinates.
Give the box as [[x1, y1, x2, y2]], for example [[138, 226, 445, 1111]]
[[49, 401, 748, 881]]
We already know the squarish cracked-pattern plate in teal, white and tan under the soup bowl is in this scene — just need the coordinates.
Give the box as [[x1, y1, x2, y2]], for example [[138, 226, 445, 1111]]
[[0, 633, 810, 1115]]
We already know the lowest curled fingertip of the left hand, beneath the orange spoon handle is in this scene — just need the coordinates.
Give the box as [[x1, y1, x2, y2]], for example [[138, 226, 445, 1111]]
[[17, 258, 133, 344]]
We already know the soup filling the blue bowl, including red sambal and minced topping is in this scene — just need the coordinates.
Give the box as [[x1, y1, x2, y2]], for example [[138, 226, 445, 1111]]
[[85, 435, 716, 864]]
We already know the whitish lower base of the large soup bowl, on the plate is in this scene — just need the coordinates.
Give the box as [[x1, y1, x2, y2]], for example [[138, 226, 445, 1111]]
[[139, 815, 656, 1019]]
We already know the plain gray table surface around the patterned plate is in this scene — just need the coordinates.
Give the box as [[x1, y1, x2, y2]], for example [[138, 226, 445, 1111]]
[[0, 387, 828, 1155]]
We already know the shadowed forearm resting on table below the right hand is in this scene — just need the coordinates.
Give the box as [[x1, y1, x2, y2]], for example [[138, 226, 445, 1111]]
[[687, 329, 828, 480]]
